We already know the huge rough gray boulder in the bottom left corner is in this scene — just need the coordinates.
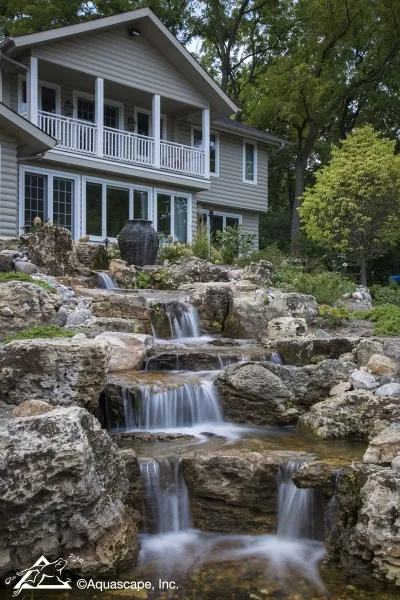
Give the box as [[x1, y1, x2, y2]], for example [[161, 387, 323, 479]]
[[0, 407, 138, 576]]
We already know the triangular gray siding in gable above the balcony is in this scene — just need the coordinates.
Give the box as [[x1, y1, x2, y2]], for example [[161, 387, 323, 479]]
[[33, 28, 208, 106]]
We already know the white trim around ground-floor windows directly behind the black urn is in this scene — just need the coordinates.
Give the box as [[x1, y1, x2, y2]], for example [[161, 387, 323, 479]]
[[82, 175, 154, 242]]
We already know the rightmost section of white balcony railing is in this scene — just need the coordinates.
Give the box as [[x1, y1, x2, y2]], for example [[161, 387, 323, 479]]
[[160, 140, 204, 176]]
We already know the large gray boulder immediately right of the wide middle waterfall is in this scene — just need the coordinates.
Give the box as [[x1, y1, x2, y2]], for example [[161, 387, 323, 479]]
[[216, 360, 354, 425]]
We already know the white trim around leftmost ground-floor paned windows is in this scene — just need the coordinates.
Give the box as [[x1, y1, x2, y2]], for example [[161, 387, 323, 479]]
[[19, 165, 81, 240]]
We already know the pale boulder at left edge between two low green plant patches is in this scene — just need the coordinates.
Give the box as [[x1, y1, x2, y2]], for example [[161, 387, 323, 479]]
[[0, 281, 62, 335]]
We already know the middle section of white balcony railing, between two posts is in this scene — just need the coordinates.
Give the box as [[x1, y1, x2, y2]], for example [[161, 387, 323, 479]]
[[104, 127, 154, 167]]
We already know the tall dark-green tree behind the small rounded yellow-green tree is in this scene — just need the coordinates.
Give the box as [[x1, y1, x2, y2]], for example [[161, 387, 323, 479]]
[[243, 0, 400, 250]]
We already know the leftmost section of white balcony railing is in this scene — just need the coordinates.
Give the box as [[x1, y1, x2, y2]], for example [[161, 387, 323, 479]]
[[39, 110, 97, 154]]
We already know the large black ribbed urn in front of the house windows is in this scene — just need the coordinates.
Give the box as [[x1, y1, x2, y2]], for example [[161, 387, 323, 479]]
[[118, 219, 158, 267]]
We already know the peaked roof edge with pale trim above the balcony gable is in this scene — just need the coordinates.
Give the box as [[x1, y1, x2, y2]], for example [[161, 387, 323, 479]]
[[0, 8, 239, 114]]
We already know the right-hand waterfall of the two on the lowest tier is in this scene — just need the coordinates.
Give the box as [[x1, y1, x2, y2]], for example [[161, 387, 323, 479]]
[[277, 461, 317, 541]]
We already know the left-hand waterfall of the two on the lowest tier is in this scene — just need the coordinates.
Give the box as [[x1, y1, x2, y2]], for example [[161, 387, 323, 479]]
[[140, 456, 192, 533]]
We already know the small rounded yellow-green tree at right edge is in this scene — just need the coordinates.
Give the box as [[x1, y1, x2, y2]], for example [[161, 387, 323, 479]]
[[298, 126, 400, 285]]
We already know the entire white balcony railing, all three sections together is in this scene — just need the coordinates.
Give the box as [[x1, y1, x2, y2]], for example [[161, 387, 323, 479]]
[[38, 111, 205, 177]]
